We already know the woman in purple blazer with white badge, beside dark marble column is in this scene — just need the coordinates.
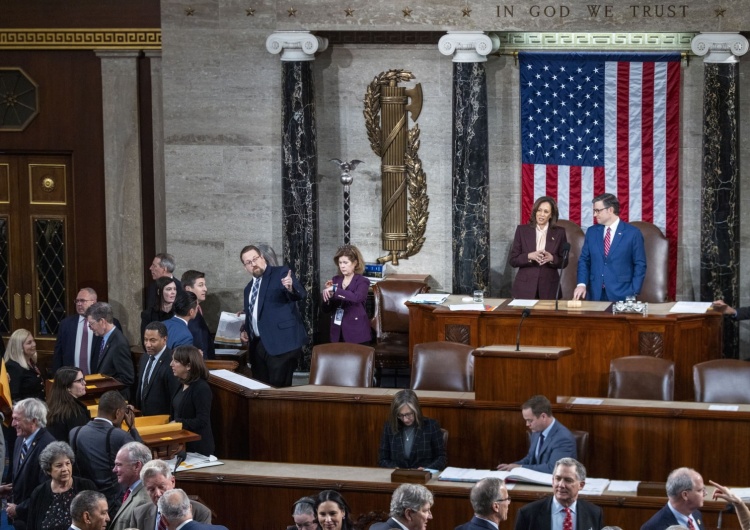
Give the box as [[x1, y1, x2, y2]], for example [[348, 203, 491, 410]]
[[322, 245, 372, 343]]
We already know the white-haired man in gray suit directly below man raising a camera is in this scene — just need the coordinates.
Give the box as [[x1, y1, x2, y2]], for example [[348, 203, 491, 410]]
[[109, 442, 151, 530]]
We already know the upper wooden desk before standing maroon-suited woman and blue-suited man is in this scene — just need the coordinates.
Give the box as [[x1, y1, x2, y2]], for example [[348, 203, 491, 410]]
[[407, 298, 722, 401]]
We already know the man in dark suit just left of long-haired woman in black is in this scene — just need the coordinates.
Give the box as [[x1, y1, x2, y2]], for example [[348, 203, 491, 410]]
[[135, 322, 180, 416]]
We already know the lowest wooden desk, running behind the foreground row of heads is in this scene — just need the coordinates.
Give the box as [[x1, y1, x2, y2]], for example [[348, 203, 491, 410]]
[[176, 460, 739, 530]]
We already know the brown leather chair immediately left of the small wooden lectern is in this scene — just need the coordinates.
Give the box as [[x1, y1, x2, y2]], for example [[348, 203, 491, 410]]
[[409, 342, 474, 392]]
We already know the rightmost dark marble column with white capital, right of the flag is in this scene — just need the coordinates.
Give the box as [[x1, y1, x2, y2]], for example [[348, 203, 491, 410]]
[[691, 33, 748, 358]]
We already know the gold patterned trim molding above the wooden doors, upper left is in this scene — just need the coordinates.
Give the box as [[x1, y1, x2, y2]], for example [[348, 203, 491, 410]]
[[0, 28, 161, 50]]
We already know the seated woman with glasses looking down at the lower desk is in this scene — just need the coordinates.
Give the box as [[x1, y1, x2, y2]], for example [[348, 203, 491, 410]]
[[378, 390, 446, 470]]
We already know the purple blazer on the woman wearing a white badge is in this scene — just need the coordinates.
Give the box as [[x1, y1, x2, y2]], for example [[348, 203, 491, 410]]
[[323, 274, 372, 343]]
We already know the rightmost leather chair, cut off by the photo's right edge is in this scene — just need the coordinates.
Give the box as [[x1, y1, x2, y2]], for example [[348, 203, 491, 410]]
[[693, 359, 750, 404]]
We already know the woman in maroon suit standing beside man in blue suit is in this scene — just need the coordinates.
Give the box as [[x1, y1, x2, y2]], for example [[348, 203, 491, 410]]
[[508, 196, 567, 300]]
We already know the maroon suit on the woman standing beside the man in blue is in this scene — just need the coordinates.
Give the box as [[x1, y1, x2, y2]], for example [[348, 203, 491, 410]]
[[508, 224, 567, 300]]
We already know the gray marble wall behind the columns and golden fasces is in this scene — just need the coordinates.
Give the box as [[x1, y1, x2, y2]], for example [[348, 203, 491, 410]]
[[162, 0, 750, 349]]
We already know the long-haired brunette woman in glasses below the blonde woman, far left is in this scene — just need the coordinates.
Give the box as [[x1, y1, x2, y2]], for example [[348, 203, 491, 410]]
[[47, 366, 91, 442]]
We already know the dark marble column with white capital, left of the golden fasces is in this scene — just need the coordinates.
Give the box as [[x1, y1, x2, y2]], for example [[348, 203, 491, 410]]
[[266, 31, 328, 369]]
